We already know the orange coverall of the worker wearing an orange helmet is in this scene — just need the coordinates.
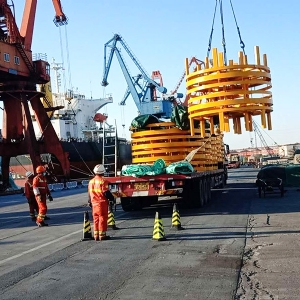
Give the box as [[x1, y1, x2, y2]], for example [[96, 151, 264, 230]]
[[33, 174, 50, 223]]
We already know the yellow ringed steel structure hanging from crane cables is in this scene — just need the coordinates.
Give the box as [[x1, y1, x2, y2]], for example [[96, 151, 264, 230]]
[[185, 46, 273, 136]]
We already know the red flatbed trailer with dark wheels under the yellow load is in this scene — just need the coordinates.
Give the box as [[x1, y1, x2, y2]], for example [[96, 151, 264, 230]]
[[106, 168, 227, 211]]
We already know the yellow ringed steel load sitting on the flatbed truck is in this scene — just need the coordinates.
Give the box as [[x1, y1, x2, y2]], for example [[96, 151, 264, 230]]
[[131, 122, 224, 171]]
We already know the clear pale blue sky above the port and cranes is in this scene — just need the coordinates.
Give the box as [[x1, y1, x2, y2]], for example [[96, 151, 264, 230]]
[[8, 0, 300, 149]]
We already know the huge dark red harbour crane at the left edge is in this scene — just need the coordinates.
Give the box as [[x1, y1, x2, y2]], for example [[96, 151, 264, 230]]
[[0, 0, 70, 189]]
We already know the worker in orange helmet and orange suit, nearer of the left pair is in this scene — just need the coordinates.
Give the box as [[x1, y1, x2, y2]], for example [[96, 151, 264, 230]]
[[33, 166, 53, 227]]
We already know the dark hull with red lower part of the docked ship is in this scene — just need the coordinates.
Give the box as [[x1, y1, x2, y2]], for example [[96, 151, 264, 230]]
[[10, 139, 132, 182]]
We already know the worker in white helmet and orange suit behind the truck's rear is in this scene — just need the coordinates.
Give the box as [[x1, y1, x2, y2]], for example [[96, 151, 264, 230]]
[[88, 165, 114, 241]]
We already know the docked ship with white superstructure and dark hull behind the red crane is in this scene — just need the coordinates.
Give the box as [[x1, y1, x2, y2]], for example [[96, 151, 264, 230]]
[[10, 59, 132, 186]]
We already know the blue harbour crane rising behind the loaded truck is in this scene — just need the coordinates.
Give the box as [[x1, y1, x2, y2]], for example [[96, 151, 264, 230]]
[[102, 34, 183, 118]]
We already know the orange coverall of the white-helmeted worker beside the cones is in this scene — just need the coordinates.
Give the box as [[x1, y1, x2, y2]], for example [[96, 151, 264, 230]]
[[88, 175, 109, 239]]
